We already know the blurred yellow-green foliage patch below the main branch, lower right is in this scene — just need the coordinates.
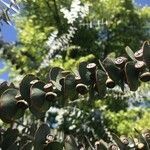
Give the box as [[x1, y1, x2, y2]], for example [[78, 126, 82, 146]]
[[105, 108, 150, 136]]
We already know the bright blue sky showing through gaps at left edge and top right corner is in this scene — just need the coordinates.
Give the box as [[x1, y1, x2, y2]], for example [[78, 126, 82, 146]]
[[0, 0, 150, 80]]
